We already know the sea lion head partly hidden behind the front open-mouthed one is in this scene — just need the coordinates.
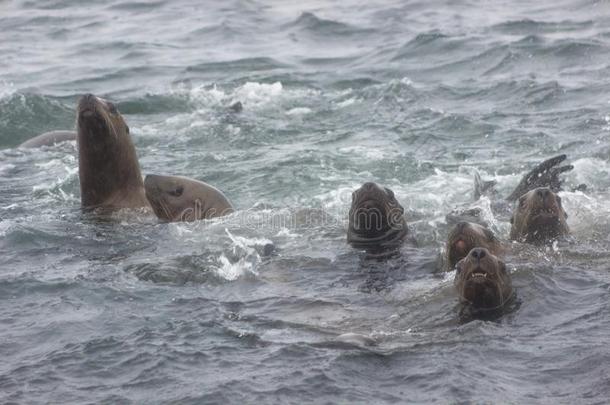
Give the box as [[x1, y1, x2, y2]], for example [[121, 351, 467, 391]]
[[446, 222, 501, 270]]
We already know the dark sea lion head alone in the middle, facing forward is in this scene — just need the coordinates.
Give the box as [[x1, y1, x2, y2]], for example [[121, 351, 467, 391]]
[[347, 182, 408, 250]]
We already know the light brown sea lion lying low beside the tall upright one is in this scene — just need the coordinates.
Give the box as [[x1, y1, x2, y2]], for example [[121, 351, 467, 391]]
[[144, 174, 234, 222]]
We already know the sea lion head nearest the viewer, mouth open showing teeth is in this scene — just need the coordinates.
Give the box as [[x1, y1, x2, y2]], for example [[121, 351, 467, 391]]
[[454, 248, 512, 310]]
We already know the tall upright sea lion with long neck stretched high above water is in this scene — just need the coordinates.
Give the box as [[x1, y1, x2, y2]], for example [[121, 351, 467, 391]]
[[76, 94, 150, 210]]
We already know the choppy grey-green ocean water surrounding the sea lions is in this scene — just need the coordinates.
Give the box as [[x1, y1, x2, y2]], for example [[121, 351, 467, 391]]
[[0, 0, 610, 404]]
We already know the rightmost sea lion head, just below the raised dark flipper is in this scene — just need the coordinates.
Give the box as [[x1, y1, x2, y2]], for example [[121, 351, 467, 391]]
[[510, 187, 570, 244]]
